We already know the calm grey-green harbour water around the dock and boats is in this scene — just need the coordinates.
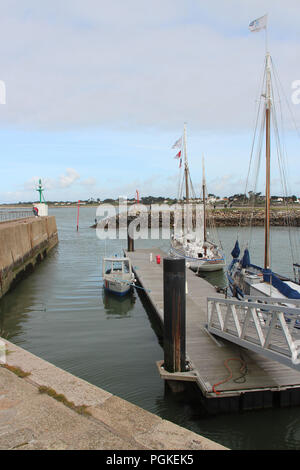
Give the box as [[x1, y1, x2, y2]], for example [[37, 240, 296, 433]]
[[0, 208, 300, 449]]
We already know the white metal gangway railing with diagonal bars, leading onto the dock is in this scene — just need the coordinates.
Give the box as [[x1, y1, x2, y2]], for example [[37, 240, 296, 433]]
[[207, 297, 300, 371]]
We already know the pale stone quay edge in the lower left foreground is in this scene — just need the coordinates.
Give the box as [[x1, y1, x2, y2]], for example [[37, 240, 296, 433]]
[[0, 338, 226, 451]]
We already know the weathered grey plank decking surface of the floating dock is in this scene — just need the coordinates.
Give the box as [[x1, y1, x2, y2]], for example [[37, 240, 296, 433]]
[[126, 248, 300, 404]]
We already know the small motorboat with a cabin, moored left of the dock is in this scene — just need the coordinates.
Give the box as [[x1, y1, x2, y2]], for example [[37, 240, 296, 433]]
[[102, 256, 135, 296]]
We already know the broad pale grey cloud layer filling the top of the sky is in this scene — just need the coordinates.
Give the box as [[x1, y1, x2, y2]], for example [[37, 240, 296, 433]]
[[0, 0, 300, 130]]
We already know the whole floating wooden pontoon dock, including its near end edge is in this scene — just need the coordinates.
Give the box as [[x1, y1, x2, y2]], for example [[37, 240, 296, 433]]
[[126, 248, 300, 411]]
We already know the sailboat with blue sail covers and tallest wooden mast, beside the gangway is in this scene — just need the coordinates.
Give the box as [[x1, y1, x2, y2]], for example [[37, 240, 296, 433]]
[[227, 17, 300, 303]]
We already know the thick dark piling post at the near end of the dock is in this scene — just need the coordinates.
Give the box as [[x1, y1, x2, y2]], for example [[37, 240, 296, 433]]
[[163, 258, 186, 372]]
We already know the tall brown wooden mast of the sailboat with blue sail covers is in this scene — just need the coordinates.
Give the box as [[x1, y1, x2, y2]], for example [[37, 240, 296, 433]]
[[265, 52, 271, 269]]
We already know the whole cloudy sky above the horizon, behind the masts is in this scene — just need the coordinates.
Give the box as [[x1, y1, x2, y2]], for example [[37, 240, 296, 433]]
[[0, 0, 300, 203]]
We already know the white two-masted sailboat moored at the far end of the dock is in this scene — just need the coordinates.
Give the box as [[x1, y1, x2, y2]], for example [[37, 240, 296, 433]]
[[170, 124, 225, 273]]
